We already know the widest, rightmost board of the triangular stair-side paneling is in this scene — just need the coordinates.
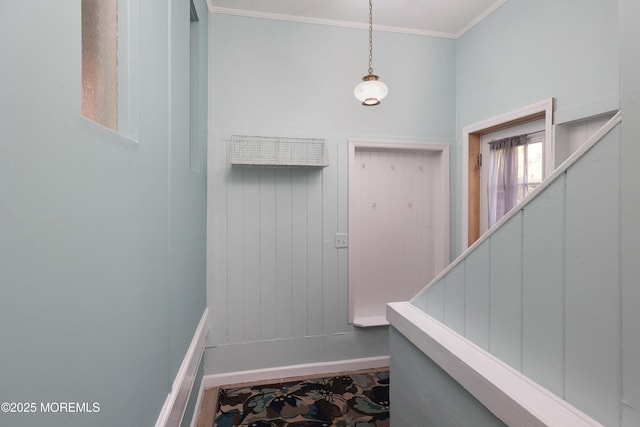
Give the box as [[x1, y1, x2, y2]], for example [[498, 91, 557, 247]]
[[565, 130, 621, 425]]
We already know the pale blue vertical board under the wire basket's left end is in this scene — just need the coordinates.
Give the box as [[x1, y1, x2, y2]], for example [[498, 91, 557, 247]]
[[226, 168, 245, 342]]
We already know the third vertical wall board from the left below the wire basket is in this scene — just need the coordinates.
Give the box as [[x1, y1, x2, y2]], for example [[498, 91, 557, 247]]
[[259, 168, 278, 339]]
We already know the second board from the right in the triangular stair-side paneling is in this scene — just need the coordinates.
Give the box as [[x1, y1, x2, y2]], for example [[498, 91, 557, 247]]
[[522, 175, 565, 396]]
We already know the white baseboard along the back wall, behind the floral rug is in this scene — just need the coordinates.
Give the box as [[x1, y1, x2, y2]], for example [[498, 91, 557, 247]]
[[202, 356, 389, 389]]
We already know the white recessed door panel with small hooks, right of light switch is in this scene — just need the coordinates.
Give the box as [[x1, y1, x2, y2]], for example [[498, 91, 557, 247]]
[[349, 141, 449, 326]]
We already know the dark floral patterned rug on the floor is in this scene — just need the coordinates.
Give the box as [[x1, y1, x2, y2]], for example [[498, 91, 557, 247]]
[[214, 370, 389, 427]]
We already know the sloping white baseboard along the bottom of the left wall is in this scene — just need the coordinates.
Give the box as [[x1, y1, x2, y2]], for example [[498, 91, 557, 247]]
[[156, 308, 209, 427]]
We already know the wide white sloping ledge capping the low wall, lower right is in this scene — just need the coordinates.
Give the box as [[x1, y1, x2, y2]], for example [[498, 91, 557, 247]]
[[387, 302, 602, 427]]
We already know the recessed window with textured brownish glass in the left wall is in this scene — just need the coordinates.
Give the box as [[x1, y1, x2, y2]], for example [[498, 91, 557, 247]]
[[82, 0, 137, 137]]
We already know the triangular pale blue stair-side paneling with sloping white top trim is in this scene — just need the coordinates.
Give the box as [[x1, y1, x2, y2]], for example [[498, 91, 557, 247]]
[[408, 113, 624, 425]]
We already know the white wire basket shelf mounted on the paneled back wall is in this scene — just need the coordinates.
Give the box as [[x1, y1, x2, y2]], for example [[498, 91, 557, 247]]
[[229, 135, 329, 167]]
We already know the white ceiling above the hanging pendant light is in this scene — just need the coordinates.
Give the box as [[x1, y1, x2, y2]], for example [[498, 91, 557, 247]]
[[207, 0, 507, 38]]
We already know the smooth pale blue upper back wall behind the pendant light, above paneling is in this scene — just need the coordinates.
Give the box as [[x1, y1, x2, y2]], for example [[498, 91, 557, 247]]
[[211, 14, 455, 139]]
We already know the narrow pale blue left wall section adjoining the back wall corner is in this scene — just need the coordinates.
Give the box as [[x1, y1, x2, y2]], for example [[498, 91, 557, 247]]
[[168, 0, 209, 384]]
